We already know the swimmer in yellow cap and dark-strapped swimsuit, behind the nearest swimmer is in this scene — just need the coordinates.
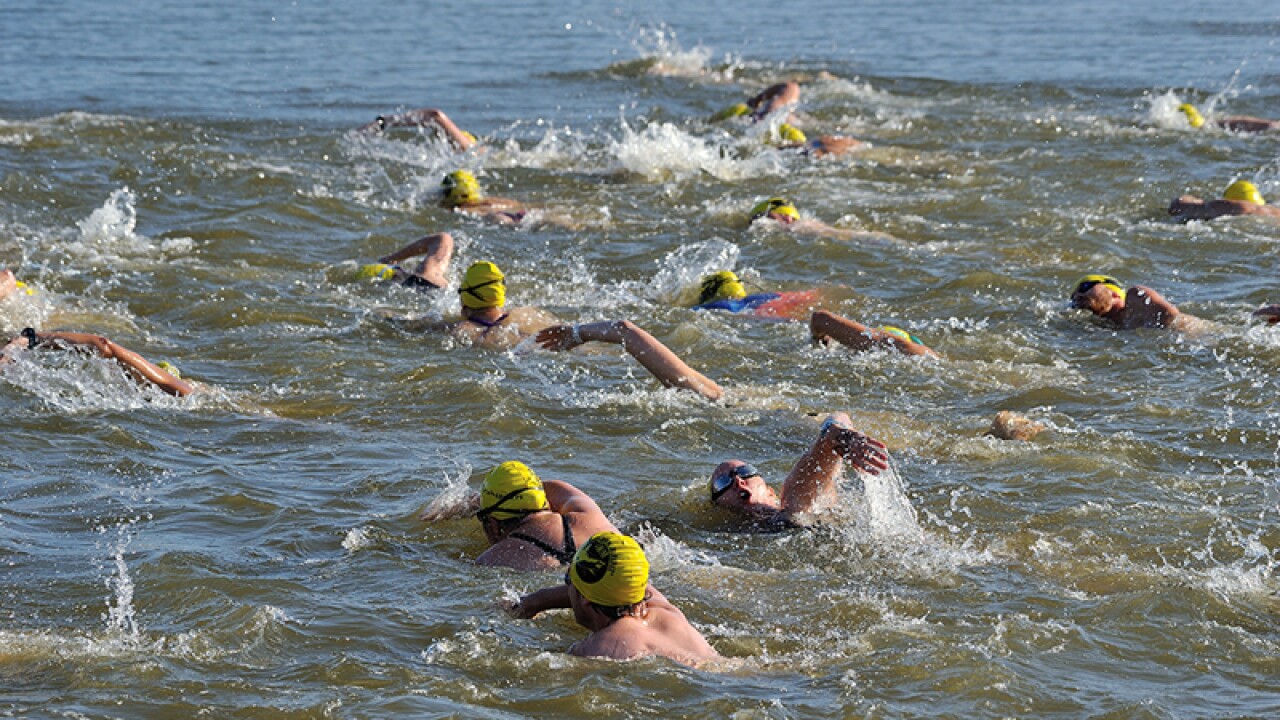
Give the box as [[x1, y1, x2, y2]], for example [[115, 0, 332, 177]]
[[424, 460, 617, 570]]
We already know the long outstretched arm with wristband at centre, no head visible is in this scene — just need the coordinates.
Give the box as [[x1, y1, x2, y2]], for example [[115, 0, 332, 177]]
[[534, 320, 724, 400]]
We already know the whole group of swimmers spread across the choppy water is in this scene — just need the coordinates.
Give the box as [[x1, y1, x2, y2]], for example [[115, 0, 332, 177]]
[[0, 82, 1280, 664]]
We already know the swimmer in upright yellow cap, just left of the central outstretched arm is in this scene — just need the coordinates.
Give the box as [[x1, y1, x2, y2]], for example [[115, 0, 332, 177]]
[[408, 260, 556, 350]]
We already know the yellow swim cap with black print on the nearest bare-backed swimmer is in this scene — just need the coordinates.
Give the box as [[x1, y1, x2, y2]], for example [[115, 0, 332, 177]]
[[568, 533, 649, 607]]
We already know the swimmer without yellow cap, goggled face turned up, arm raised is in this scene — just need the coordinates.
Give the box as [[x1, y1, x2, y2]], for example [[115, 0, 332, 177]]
[[707, 413, 888, 529]]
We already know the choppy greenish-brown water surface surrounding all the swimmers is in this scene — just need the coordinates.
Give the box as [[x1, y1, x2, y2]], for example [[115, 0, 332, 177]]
[[0, 3, 1280, 717]]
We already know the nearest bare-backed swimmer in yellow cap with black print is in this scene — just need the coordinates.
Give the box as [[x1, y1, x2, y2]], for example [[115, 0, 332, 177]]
[[507, 533, 719, 666]]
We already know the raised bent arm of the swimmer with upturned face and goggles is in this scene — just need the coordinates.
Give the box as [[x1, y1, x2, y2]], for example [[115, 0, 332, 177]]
[[782, 413, 888, 512]]
